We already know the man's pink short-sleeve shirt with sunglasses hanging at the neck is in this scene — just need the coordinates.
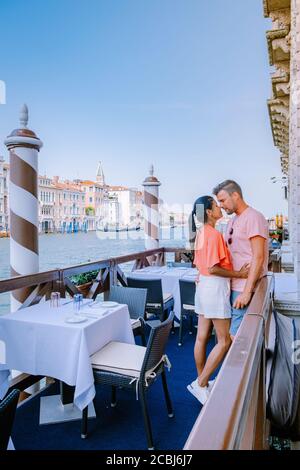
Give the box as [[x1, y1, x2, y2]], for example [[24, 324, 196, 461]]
[[225, 207, 269, 292]]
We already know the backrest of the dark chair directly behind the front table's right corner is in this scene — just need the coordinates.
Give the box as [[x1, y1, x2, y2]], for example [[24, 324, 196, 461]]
[[108, 286, 147, 318]]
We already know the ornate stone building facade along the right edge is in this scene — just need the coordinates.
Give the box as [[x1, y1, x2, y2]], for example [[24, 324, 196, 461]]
[[263, 0, 300, 303]]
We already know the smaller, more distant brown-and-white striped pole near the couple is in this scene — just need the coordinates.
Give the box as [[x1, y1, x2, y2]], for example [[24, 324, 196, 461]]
[[143, 165, 161, 260]]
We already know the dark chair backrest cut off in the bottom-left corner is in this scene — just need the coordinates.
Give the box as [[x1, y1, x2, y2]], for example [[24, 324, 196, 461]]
[[0, 389, 20, 450]]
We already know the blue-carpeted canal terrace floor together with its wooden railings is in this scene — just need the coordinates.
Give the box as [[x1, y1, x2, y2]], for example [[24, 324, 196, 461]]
[[0, 248, 278, 451]]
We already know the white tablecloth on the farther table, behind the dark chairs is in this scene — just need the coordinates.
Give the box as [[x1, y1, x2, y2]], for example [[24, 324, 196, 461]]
[[128, 266, 198, 318]]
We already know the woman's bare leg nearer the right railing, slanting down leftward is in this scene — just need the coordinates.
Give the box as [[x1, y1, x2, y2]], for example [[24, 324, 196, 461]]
[[198, 318, 231, 387]]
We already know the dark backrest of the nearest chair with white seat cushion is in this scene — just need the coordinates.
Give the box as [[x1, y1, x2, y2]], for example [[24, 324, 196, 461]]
[[141, 312, 174, 379]]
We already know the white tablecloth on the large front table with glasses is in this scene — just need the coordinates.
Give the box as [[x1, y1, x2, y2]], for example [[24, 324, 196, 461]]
[[0, 300, 134, 410]]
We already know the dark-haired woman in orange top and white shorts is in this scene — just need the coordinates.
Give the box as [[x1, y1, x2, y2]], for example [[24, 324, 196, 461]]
[[187, 196, 248, 404]]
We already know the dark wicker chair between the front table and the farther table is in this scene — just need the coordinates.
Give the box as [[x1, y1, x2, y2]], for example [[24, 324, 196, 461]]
[[108, 286, 147, 346]]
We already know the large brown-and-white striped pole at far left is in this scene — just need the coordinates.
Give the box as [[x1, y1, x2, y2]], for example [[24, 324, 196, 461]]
[[4, 105, 43, 312]]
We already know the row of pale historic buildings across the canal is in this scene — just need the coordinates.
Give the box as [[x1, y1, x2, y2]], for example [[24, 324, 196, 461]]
[[0, 161, 142, 233]]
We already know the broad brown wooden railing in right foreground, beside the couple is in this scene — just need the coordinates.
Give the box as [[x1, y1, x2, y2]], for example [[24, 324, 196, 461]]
[[184, 275, 274, 450]]
